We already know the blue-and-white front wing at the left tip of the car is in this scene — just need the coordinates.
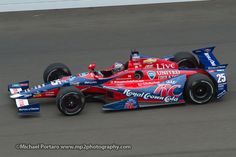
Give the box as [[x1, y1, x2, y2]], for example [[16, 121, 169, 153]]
[[8, 81, 40, 114]]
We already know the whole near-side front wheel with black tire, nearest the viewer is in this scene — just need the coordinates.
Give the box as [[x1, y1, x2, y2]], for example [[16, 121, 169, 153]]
[[56, 86, 85, 116]]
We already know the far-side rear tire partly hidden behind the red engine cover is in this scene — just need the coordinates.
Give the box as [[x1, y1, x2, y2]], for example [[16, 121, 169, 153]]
[[173, 52, 199, 68]]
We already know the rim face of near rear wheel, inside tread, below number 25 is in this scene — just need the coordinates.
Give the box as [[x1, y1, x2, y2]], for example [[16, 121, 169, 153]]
[[190, 81, 214, 104]]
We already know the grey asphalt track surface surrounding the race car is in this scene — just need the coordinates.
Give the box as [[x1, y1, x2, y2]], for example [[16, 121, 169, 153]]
[[0, 0, 236, 157]]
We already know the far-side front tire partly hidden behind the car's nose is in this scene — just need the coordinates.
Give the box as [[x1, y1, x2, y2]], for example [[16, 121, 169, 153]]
[[43, 63, 71, 83]]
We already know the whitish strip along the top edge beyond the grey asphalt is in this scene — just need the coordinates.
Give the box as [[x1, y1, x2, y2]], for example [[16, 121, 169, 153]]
[[0, 0, 205, 12]]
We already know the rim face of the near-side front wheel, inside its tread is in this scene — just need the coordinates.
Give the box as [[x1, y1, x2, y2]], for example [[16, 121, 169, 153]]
[[61, 92, 83, 114]]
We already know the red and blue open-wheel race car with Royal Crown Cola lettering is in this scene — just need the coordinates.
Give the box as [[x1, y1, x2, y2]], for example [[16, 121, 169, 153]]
[[8, 47, 227, 116]]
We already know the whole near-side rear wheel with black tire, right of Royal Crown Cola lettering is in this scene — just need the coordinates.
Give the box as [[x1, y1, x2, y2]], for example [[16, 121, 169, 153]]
[[185, 74, 216, 105]]
